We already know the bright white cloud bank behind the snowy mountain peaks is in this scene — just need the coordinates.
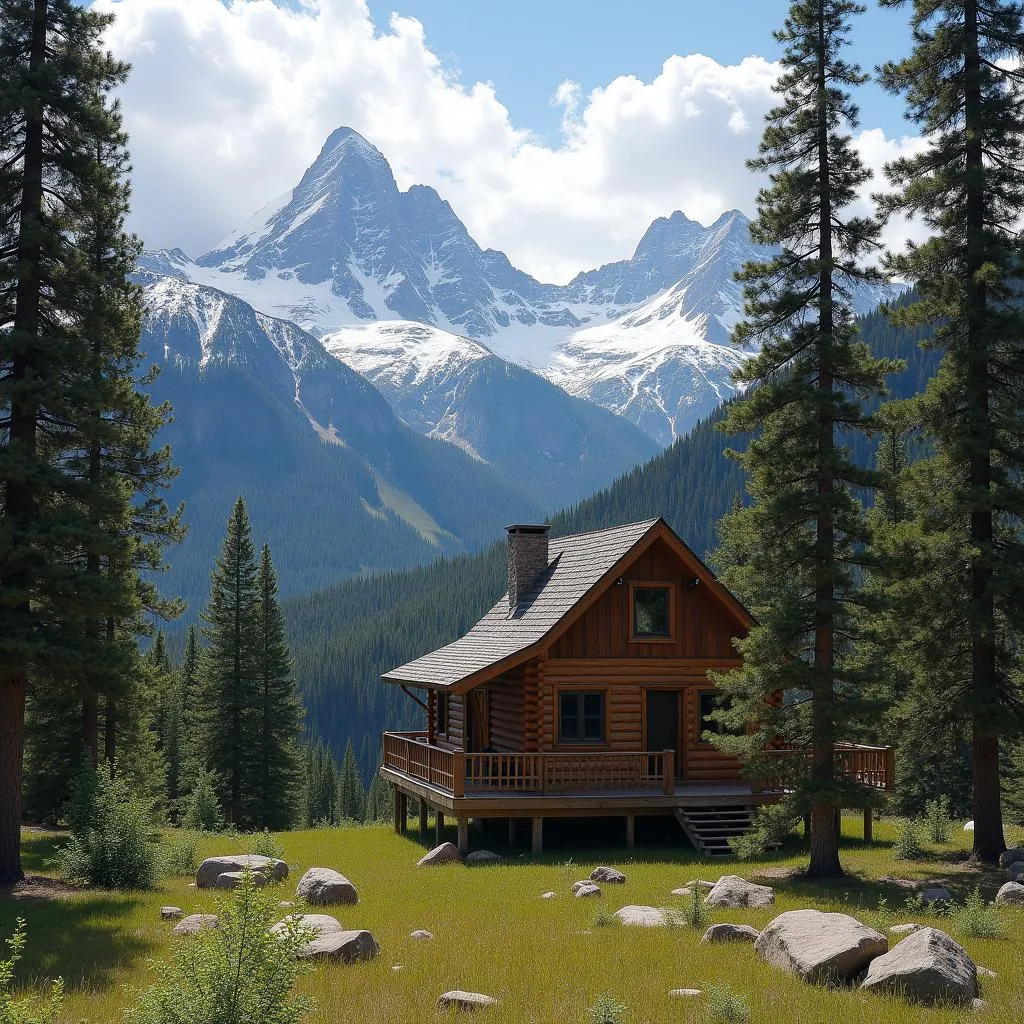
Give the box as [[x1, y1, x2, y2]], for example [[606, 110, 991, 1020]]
[[96, 0, 921, 281]]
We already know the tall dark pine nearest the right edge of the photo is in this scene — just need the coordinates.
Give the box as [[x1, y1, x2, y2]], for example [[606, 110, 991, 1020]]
[[882, 0, 1024, 862]]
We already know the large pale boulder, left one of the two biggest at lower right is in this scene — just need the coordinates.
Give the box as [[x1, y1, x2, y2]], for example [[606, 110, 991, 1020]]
[[754, 910, 889, 984]]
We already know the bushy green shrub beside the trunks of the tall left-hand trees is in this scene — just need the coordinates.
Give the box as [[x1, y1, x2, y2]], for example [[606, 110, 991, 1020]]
[[57, 764, 157, 889]]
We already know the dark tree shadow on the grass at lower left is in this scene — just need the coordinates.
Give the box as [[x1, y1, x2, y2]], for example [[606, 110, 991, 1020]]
[[0, 890, 157, 992]]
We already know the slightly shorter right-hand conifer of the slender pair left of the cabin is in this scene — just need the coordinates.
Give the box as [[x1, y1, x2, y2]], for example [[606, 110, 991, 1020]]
[[248, 545, 305, 829]]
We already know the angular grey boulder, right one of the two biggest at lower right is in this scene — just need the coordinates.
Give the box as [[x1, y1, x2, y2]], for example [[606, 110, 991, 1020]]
[[860, 928, 978, 1006]]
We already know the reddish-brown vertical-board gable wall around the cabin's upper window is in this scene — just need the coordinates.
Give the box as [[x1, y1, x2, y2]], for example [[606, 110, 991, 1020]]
[[548, 541, 736, 660]]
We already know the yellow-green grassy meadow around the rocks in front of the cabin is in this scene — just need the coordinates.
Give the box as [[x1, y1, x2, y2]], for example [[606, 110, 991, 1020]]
[[0, 817, 1024, 1024]]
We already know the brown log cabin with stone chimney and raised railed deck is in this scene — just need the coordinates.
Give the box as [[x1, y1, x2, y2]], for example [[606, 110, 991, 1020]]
[[381, 518, 893, 854]]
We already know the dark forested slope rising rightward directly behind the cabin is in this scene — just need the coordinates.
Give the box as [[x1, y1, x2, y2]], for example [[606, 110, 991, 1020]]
[[285, 303, 936, 774]]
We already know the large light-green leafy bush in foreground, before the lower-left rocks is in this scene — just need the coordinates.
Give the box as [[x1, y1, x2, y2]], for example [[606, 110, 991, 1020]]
[[125, 871, 313, 1024]]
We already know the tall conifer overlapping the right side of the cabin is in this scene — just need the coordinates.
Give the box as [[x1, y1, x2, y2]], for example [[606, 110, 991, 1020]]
[[718, 0, 895, 878]]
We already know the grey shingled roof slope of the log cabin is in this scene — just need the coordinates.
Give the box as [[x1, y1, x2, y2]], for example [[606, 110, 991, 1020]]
[[384, 519, 660, 687]]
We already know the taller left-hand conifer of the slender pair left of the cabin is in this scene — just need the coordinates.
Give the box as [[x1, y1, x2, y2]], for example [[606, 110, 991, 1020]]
[[200, 498, 260, 828]]
